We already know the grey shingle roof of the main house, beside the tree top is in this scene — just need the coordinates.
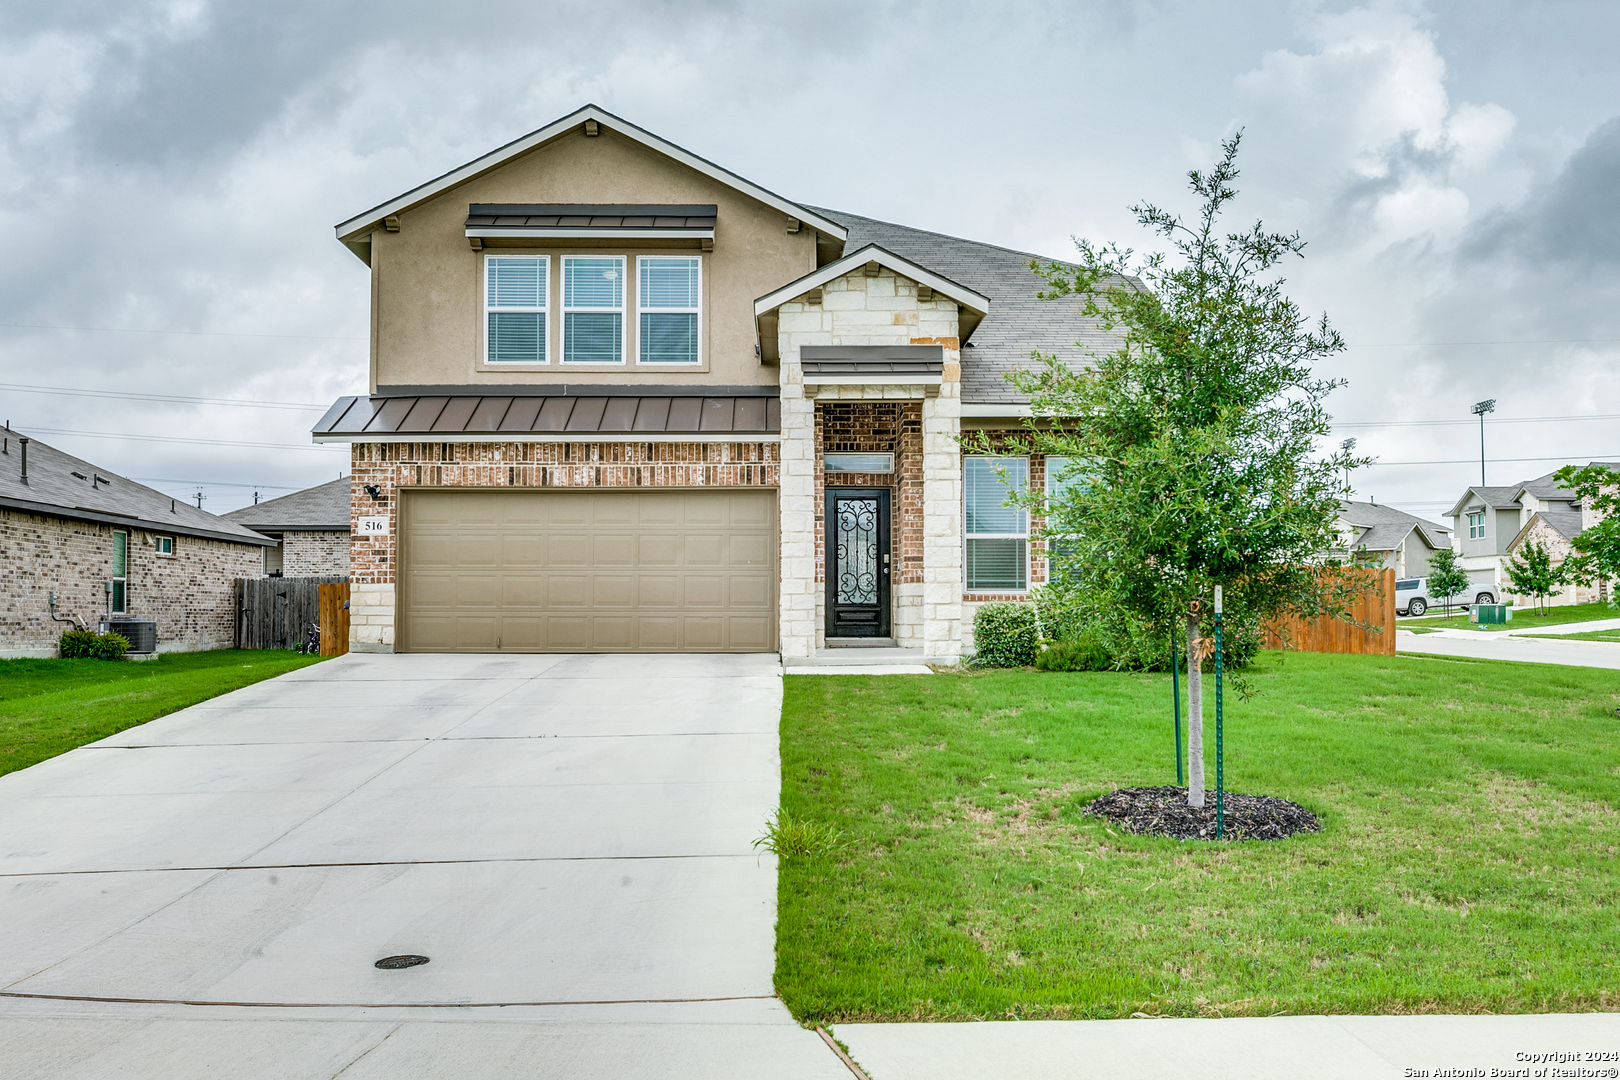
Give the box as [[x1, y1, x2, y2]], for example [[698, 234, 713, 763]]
[[808, 207, 1119, 405]]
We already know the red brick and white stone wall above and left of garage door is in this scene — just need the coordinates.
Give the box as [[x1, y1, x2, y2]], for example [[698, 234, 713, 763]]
[[348, 442, 778, 653]]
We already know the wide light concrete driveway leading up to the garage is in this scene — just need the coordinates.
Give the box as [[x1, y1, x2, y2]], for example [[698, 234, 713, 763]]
[[0, 656, 849, 1080]]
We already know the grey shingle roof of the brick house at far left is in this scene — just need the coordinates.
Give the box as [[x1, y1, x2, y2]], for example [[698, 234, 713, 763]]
[[0, 427, 271, 547]]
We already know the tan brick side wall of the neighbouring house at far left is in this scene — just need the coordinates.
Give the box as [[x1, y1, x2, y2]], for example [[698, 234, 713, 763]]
[[0, 510, 262, 656]]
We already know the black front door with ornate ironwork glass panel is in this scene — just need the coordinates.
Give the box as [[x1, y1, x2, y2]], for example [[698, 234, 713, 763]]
[[826, 487, 889, 638]]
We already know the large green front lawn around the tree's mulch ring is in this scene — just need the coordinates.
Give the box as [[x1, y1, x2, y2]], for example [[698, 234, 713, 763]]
[[776, 653, 1620, 1023]]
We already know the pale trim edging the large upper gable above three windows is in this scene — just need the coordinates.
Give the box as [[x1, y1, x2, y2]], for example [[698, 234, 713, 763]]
[[334, 105, 849, 259]]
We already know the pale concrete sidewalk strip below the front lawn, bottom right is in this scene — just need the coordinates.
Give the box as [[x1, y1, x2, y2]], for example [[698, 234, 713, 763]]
[[834, 1014, 1620, 1080]]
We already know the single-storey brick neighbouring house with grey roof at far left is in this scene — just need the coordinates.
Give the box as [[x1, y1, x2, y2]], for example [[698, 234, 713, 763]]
[[0, 427, 274, 657]]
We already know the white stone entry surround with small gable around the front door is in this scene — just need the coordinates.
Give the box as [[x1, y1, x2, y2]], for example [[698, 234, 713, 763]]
[[778, 267, 962, 664]]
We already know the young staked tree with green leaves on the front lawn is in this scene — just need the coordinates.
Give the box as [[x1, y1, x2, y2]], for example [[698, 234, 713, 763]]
[[985, 134, 1371, 806]]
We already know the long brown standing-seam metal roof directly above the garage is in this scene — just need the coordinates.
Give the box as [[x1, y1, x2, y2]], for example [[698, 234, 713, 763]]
[[311, 392, 782, 442]]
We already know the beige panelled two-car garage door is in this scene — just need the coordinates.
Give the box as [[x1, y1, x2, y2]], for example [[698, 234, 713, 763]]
[[399, 489, 776, 653]]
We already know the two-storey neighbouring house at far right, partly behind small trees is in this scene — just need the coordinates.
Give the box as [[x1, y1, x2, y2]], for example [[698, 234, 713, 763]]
[[1447, 461, 1620, 604]]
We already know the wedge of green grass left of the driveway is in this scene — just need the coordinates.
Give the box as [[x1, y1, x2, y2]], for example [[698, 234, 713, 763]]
[[0, 649, 319, 776]]
